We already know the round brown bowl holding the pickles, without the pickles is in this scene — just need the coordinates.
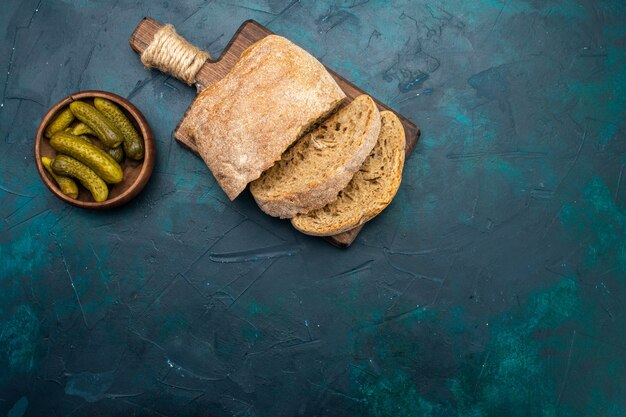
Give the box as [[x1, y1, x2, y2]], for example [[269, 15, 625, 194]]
[[35, 90, 155, 209]]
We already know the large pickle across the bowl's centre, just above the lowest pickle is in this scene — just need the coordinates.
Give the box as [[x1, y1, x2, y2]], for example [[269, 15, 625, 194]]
[[50, 132, 124, 184]]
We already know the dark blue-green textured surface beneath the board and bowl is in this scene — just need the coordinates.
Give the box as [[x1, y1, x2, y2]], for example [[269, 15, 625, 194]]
[[0, 0, 626, 417]]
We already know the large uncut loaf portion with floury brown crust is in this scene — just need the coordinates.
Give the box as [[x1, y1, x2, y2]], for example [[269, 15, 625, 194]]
[[178, 35, 345, 200]]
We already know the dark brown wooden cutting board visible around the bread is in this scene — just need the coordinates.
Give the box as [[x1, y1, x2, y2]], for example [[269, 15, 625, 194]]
[[129, 17, 420, 247]]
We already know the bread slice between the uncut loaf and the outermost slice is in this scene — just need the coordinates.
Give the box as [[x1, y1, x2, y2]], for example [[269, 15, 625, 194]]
[[250, 95, 380, 218]]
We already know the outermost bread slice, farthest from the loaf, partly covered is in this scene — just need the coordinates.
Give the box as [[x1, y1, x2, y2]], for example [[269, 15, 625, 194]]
[[291, 111, 405, 236]]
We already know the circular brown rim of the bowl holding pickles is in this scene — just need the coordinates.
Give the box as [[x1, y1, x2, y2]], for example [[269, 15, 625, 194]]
[[35, 90, 155, 209]]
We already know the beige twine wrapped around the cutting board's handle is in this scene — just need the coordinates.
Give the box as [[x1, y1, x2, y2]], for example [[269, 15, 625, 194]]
[[141, 24, 210, 85]]
